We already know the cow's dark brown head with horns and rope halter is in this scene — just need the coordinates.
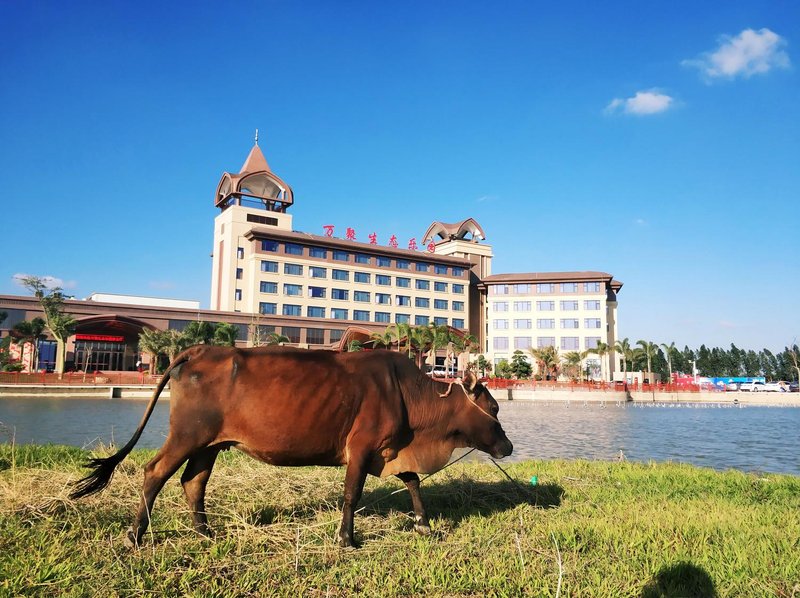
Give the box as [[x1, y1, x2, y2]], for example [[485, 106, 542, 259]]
[[453, 372, 514, 459]]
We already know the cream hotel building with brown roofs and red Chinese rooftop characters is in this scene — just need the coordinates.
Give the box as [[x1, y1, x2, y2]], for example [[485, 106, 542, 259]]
[[0, 142, 622, 378]]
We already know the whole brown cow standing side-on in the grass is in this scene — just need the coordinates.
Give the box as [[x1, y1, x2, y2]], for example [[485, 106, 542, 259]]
[[71, 346, 513, 546]]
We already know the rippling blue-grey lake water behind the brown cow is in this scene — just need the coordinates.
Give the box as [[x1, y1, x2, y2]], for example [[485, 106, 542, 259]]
[[0, 399, 800, 475]]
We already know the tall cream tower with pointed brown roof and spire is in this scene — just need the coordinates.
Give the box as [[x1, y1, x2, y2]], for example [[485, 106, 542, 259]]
[[210, 138, 294, 311]]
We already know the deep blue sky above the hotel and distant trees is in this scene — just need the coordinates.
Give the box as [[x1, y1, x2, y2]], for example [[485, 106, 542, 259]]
[[0, 0, 800, 349]]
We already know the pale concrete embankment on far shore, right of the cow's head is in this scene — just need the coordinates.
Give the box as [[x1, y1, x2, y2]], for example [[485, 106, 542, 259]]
[[492, 388, 800, 407]]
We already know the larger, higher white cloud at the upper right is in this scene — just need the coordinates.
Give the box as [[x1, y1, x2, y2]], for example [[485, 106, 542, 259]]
[[682, 28, 791, 79]]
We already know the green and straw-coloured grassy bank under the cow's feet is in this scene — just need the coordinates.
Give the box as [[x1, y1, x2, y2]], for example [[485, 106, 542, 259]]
[[0, 444, 800, 598]]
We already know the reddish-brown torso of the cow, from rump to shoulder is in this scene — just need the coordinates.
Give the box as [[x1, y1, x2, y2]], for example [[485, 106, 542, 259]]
[[170, 347, 403, 465]]
